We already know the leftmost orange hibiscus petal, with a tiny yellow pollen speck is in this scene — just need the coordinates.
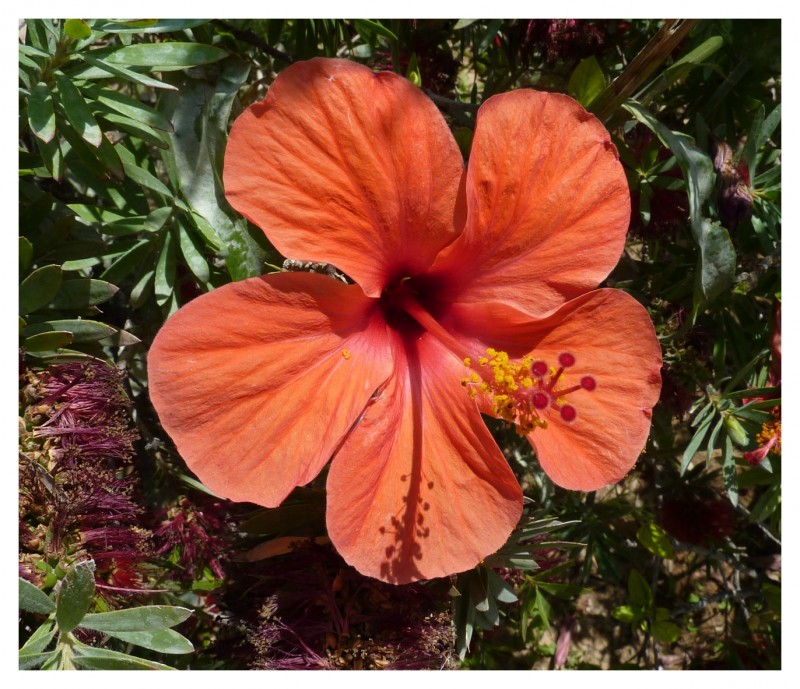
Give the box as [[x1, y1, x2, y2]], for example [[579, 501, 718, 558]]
[[148, 273, 391, 507]]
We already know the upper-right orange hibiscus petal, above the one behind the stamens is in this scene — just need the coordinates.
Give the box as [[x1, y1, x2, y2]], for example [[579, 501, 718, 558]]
[[434, 89, 630, 316]]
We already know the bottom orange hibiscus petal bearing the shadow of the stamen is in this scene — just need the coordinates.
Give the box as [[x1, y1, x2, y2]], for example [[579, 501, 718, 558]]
[[328, 335, 522, 584]]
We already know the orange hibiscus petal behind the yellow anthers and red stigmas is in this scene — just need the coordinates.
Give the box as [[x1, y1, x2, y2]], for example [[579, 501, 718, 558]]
[[440, 289, 661, 491]]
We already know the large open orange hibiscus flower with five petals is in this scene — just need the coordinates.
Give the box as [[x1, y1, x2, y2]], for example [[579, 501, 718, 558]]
[[149, 59, 661, 583]]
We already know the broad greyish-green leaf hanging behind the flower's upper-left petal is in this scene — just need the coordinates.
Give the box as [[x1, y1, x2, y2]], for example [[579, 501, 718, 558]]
[[162, 58, 266, 280]]
